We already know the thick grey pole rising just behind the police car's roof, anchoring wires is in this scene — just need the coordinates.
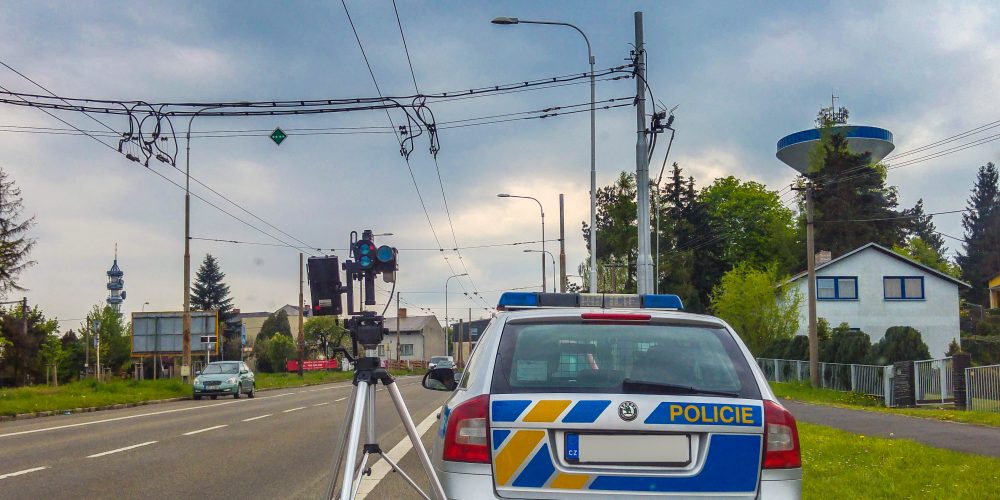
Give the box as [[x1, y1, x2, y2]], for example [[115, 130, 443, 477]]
[[635, 11, 653, 294]]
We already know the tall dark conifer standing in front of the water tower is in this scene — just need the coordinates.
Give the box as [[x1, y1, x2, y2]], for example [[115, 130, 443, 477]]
[[800, 128, 909, 257]]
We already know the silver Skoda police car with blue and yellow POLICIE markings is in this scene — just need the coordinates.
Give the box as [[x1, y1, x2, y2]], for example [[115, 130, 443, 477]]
[[424, 292, 802, 499]]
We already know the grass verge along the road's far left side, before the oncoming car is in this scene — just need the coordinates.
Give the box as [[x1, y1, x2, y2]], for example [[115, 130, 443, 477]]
[[0, 379, 191, 415]]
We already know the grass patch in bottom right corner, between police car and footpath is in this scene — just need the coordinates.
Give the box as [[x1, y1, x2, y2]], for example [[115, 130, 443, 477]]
[[798, 422, 1000, 499]]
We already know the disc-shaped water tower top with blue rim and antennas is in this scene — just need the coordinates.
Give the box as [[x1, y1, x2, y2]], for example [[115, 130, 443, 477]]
[[777, 96, 896, 174]]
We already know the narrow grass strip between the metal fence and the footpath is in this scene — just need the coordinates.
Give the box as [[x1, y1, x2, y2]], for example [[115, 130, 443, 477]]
[[771, 382, 1000, 427]]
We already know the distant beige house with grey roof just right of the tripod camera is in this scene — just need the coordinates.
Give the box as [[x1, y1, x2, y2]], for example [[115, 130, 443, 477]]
[[378, 309, 447, 361]]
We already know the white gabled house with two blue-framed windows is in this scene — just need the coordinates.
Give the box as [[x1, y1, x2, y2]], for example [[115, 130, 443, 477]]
[[787, 243, 969, 358]]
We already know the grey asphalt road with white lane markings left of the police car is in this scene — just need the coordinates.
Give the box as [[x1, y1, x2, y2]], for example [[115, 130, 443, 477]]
[[0, 377, 447, 500]]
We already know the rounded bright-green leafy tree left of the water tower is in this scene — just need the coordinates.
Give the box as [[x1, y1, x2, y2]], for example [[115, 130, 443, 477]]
[[698, 176, 802, 273]]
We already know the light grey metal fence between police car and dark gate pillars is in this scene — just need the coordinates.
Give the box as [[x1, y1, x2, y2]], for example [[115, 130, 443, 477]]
[[757, 358, 895, 406]]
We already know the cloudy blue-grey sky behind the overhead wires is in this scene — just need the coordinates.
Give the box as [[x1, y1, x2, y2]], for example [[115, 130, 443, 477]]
[[0, 0, 1000, 330]]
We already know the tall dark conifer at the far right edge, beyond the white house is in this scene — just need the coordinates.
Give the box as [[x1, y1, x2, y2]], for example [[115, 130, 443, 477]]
[[958, 163, 1000, 306]]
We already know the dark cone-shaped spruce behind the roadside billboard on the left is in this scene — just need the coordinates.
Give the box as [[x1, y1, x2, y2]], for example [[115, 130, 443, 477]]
[[191, 254, 242, 359]]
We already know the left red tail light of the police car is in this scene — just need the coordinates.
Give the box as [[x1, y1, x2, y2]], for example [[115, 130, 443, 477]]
[[443, 394, 490, 464]]
